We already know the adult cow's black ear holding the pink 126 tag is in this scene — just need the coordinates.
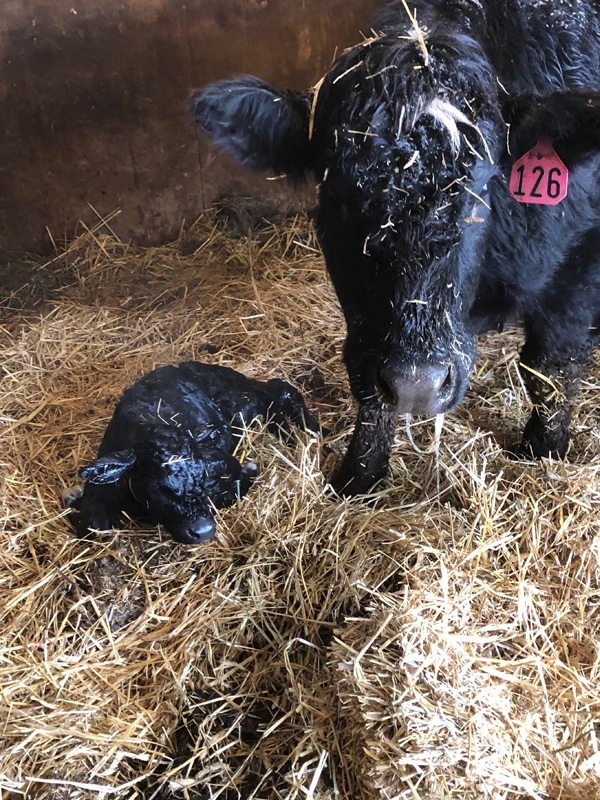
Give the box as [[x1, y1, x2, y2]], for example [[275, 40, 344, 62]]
[[502, 91, 600, 163]]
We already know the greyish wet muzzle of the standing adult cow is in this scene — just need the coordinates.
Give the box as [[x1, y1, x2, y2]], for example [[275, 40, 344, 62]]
[[381, 364, 455, 416]]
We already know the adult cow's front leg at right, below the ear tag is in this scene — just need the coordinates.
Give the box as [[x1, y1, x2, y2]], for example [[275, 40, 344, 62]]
[[520, 316, 592, 458]]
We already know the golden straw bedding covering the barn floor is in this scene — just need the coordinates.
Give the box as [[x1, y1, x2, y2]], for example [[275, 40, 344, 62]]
[[0, 208, 600, 800]]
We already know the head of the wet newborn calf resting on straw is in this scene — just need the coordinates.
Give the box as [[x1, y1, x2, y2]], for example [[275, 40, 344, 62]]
[[79, 426, 255, 544]]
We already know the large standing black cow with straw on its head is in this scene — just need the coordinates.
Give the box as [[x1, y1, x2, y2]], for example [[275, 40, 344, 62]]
[[193, 0, 600, 493]]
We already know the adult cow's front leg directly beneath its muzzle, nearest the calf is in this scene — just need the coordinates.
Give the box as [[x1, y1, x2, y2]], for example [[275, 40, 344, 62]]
[[332, 402, 398, 497]]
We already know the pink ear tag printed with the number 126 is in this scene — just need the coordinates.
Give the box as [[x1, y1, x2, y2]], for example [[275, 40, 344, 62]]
[[508, 139, 569, 206]]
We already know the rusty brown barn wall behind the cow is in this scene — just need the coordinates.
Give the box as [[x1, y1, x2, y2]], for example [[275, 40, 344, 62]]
[[0, 0, 379, 259]]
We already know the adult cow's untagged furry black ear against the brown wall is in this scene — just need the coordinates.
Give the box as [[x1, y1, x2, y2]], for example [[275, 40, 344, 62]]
[[191, 76, 310, 178]]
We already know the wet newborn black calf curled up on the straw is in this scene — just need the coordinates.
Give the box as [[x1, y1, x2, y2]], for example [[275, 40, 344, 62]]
[[73, 361, 319, 543]]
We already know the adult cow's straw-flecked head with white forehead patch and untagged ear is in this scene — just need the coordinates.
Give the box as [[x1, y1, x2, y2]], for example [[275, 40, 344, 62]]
[[193, 28, 502, 415]]
